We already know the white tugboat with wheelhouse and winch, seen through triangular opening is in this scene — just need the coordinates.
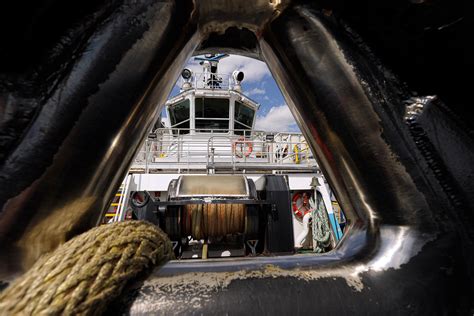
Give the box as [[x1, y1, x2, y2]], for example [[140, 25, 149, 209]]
[[104, 54, 345, 259]]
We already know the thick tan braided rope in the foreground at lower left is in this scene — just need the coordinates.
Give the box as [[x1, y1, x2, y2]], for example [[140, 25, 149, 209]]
[[0, 221, 172, 315]]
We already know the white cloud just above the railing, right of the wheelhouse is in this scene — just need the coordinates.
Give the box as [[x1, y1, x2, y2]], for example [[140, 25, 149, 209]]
[[255, 105, 298, 132]]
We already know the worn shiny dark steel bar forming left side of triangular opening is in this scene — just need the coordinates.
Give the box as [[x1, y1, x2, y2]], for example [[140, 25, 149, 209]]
[[0, 1, 200, 274]]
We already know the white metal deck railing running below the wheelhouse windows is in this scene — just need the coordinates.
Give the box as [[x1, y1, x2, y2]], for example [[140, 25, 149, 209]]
[[132, 128, 317, 173]]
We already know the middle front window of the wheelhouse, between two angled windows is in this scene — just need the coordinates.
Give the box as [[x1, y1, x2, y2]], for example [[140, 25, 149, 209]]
[[195, 98, 229, 133]]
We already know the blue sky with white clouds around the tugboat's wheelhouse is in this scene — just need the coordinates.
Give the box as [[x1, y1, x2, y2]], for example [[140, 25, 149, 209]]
[[165, 55, 299, 132]]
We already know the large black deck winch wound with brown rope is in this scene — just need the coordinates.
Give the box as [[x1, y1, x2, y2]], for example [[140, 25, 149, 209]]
[[131, 175, 294, 259]]
